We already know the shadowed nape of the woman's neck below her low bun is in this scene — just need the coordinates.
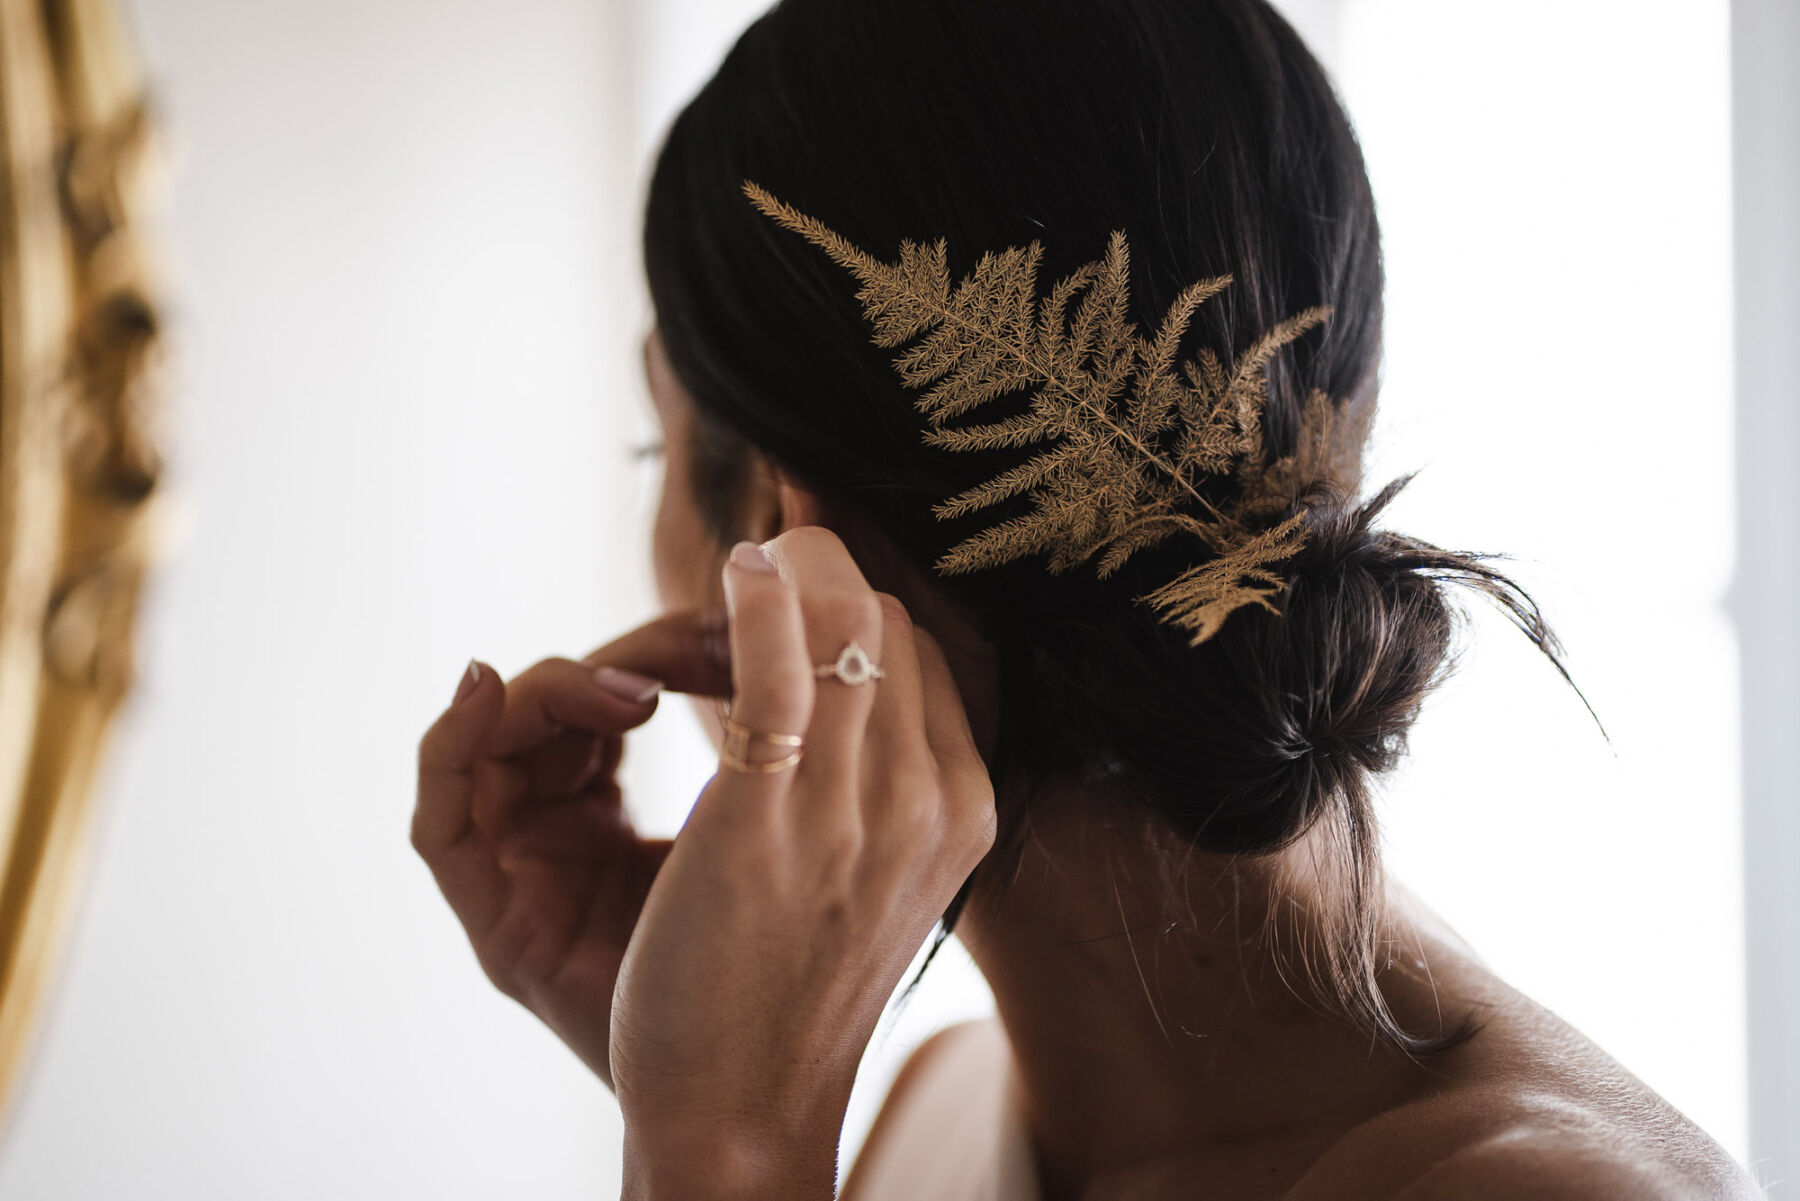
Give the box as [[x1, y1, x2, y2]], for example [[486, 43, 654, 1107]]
[[958, 787, 1461, 1197]]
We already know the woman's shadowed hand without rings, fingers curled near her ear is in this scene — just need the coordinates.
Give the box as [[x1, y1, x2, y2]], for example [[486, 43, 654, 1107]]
[[412, 614, 731, 1086]]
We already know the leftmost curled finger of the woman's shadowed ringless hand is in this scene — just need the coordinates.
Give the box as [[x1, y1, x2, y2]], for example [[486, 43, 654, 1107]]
[[412, 663, 506, 935]]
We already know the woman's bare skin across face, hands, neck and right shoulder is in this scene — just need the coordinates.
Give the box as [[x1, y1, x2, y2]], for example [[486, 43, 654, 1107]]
[[414, 331, 1760, 1201]]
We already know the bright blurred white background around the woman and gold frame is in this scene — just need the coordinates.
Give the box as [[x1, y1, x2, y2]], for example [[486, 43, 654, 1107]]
[[0, 0, 1800, 1201]]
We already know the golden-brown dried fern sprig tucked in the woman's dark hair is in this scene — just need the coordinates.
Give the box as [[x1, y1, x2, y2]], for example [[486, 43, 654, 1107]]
[[743, 180, 1341, 646]]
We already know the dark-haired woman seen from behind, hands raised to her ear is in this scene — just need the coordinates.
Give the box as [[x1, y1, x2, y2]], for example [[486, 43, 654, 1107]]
[[414, 0, 1755, 1201]]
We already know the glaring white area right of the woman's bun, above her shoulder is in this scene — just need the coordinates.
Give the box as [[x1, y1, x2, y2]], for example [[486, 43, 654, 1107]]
[[1341, 0, 1748, 1158]]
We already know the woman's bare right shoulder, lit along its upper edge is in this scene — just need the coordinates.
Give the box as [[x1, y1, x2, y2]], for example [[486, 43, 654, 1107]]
[[1287, 992, 1764, 1201]]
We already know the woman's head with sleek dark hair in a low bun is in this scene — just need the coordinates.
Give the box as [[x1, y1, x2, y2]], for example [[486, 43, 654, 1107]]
[[644, 0, 1591, 1048]]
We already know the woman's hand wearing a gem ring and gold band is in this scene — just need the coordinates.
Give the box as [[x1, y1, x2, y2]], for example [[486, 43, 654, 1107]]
[[610, 526, 995, 1199]]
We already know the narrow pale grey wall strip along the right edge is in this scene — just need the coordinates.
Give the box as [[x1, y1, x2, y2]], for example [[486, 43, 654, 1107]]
[[1728, 0, 1800, 1196]]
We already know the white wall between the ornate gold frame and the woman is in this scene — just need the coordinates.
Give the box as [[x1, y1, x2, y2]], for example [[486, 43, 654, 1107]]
[[0, 0, 648, 1201]]
